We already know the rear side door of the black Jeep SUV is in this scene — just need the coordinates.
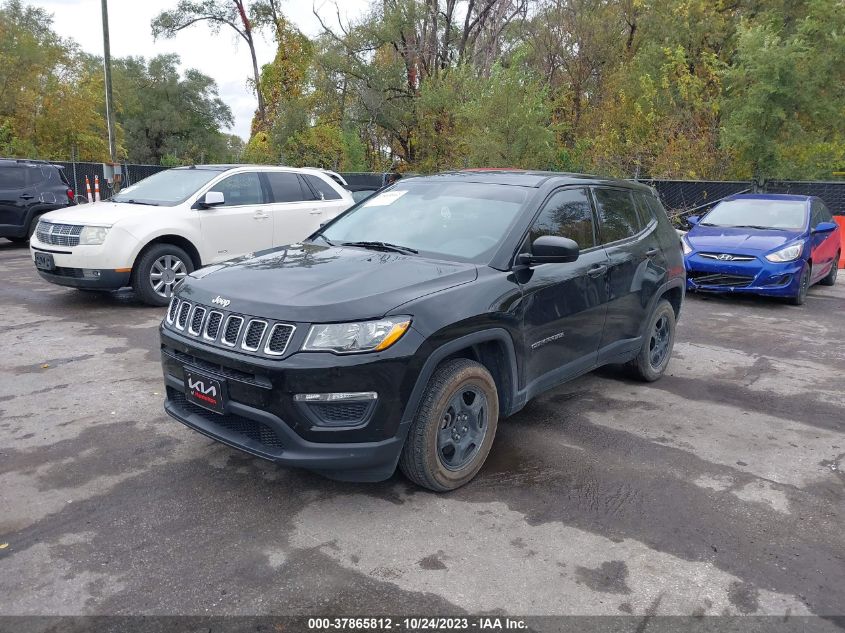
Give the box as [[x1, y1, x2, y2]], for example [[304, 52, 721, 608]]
[[593, 187, 666, 362]]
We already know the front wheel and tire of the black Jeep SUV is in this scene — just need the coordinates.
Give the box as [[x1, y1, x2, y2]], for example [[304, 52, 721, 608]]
[[399, 358, 499, 492]]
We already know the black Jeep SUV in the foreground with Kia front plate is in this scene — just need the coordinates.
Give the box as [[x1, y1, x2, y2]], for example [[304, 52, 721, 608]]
[[161, 171, 685, 491]]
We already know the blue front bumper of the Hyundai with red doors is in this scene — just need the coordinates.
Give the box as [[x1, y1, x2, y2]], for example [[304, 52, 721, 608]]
[[684, 253, 805, 297]]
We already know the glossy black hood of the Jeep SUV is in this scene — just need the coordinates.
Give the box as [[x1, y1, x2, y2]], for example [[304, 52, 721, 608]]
[[178, 244, 478, 323]]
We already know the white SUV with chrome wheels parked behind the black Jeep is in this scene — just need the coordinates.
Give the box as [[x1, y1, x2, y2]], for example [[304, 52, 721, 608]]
[[30, 165, 353, 305]]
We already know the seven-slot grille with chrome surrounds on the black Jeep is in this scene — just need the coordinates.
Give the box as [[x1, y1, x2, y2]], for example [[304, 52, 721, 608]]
[[164, 297, 296, 357]]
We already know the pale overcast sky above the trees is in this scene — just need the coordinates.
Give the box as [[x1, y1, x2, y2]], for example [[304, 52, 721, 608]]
[[33, 0, 369, 140]]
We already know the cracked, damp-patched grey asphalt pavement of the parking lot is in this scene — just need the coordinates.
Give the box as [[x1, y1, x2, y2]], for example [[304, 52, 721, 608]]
[[0, 240, 845, 616]]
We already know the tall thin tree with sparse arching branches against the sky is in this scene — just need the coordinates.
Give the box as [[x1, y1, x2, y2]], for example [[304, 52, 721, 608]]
[[152, 0, 268, 124]]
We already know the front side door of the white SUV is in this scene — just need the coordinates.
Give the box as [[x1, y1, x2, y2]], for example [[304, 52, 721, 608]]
[[197, 171, 273, 264]]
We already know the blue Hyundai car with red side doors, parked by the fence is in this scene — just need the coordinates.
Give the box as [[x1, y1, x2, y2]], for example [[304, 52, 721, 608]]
[[681, 194, 842, 305]]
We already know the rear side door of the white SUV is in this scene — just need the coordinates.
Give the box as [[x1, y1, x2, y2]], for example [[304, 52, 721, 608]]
[[263, 171, 324, 246]]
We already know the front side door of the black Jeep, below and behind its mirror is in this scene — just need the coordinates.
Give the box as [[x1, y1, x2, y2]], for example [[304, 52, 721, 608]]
[[520, 188, 608, 392]]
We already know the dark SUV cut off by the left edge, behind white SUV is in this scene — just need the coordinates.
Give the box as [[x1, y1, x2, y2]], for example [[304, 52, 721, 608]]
[[0, 158, 74, 242]]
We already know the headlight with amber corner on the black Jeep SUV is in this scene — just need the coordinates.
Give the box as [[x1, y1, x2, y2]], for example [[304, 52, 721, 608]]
[[302, 316, 411, 354]]
